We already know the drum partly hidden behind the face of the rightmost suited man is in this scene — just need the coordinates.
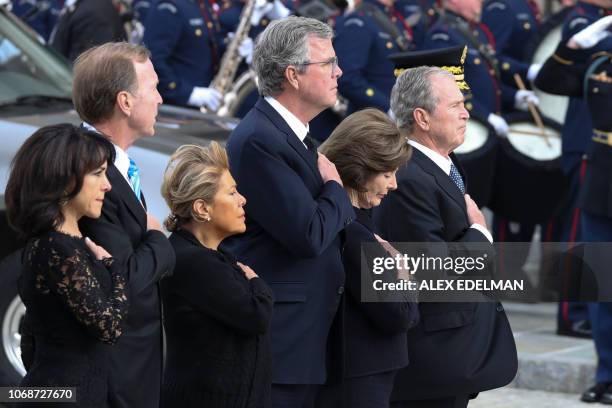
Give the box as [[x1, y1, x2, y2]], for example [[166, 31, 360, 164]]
[[454, 116, 497, 207]]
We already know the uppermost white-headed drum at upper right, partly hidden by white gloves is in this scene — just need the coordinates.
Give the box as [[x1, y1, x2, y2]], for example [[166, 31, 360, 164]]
[[525, 7, 571, 124]]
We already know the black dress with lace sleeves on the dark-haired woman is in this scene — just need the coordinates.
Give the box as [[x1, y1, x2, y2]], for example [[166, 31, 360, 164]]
[[19, 231, 128, 408]]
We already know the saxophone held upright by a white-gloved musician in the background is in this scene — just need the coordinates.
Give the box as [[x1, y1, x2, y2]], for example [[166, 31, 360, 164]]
[[200, 0, 255, 116]]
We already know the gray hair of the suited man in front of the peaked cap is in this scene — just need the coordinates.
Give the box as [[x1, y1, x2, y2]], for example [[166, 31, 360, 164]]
[[391, 66, 454, 133]]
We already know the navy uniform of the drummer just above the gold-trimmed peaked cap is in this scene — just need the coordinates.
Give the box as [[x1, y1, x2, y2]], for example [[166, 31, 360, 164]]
[[423, 10, 524, 121]]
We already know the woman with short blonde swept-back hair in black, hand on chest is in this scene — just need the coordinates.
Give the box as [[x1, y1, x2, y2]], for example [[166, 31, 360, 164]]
[[162, 142, 273, 408]]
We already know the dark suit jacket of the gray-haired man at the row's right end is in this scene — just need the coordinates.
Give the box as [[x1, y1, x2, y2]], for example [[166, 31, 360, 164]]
[[375, 149, 518, 401]]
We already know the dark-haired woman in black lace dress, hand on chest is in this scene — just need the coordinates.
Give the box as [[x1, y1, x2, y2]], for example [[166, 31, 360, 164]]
[[5, 124, 128, 407]]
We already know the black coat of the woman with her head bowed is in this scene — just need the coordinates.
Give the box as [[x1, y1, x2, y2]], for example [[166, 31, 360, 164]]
[[342, 208, 418, 378]]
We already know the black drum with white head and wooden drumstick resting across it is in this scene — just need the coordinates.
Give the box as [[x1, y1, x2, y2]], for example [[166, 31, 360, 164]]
[[489, 113, 566, 223]]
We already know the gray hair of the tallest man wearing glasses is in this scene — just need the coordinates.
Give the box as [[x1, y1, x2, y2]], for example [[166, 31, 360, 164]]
[[253, 16, 334, 96]]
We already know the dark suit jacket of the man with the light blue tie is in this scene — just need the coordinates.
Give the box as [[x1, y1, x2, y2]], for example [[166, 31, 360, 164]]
[[79, 166, 174, 407]]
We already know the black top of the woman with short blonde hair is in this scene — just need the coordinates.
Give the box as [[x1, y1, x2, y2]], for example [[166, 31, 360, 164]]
[[162, 230, 273, 408]]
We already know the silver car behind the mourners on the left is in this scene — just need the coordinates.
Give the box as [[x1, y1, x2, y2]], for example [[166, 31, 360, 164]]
[[0, 4, 238, 386]]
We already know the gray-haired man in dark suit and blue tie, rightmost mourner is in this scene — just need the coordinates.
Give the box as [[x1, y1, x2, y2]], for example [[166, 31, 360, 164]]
[[375, 59, 517, 408]]
